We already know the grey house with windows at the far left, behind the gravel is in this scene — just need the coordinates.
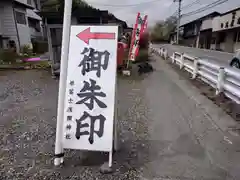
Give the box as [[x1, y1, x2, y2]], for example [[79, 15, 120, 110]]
[[0, 0, 43, 52]]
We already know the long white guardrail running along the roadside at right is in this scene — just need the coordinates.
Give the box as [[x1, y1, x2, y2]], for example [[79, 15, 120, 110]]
[[150, 46, 240, 104]]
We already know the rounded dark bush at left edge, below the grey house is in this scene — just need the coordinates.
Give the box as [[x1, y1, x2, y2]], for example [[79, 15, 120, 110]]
[[0, 49, 19, 64]]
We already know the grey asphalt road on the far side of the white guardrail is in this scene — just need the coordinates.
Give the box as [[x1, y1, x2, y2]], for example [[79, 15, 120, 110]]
[[154, 44, 233, 66]]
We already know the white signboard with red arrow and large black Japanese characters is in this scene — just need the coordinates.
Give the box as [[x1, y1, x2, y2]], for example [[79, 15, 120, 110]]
[[63, 26, 118, 152]]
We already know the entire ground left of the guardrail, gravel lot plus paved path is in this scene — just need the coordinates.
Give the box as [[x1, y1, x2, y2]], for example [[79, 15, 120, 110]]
[[0, 57, 240, 180]]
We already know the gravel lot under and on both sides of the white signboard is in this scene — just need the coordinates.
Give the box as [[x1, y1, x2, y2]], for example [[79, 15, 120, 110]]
[[0, 70, 149, 180]]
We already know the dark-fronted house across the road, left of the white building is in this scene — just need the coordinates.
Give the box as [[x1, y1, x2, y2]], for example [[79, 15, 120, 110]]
[[180, 12, 220, 49]]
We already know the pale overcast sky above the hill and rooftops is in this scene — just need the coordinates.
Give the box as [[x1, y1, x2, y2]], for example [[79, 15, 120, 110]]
[[86, 0, 240, 26]]
